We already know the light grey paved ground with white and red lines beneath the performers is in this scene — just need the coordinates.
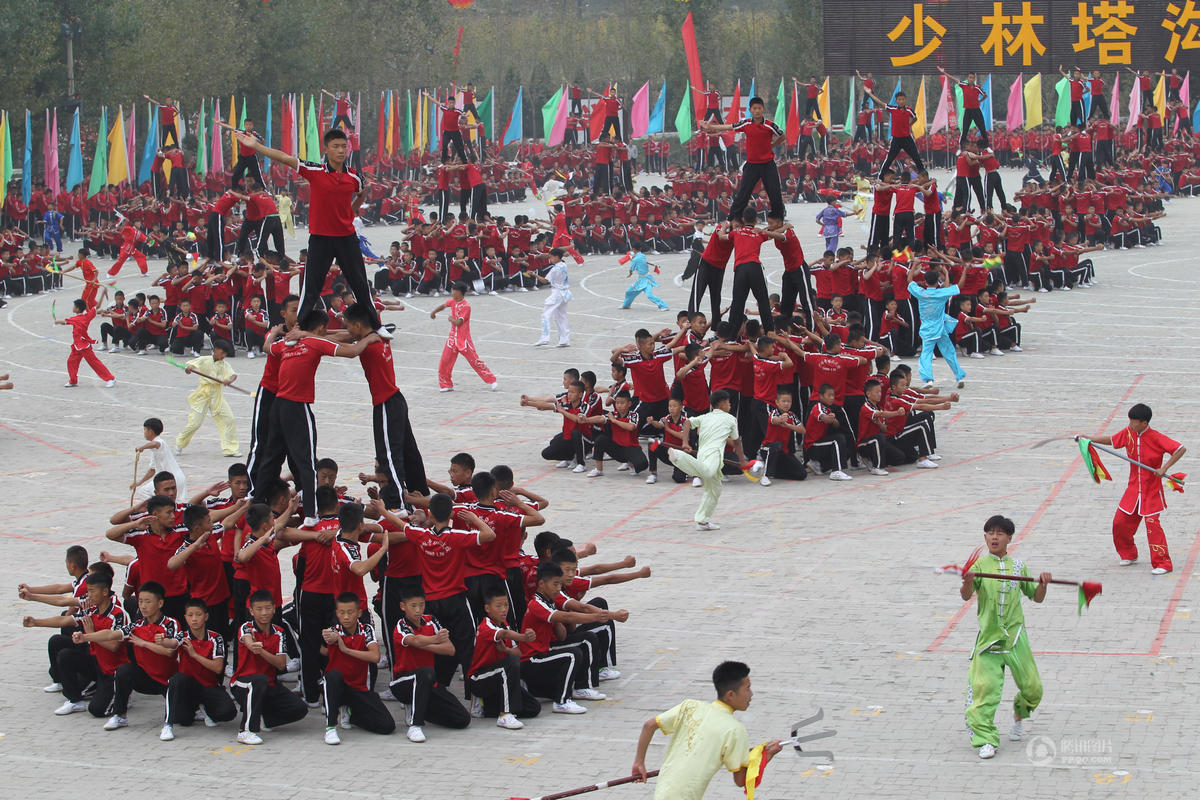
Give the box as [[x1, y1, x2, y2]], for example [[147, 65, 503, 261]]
[[0, 175, 1200, 800]]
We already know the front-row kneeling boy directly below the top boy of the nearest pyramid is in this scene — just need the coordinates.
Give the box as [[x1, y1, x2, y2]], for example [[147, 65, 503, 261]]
[[320, 591, 396, 745]]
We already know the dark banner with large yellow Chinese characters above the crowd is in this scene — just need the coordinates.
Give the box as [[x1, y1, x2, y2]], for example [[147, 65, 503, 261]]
[[824, 0, 1200, 74]]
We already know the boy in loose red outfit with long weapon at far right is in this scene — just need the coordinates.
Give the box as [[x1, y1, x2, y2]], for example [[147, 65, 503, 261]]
[[1092, 403, 1188, 575]]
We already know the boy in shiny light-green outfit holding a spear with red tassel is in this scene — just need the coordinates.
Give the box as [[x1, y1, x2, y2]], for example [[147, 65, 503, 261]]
[[959, 515, 1051, 758]]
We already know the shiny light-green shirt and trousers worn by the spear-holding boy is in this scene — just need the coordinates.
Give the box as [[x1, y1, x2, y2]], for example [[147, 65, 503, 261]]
[[966, 553, 1042, 747]]
